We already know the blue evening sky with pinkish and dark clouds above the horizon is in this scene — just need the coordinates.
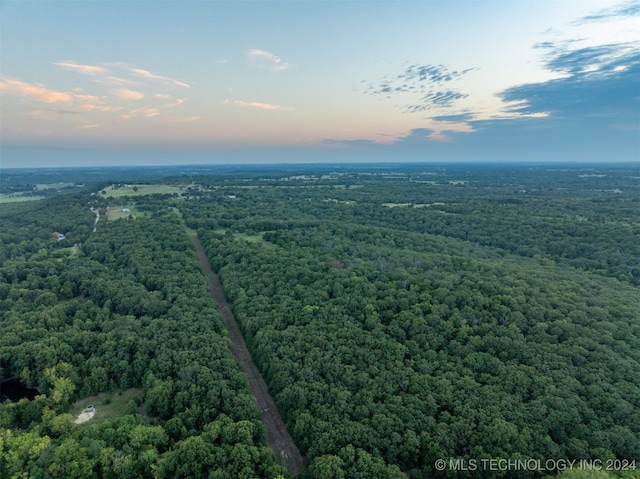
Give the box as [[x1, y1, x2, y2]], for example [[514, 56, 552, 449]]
[[0, 0, 640, 168]]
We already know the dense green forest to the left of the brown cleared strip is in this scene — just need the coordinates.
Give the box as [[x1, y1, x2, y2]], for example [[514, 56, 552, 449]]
[[0, 189, 285, 478]]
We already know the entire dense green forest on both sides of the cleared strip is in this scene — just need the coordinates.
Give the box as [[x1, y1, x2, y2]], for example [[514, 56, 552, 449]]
[[0, 165, 640, 478]]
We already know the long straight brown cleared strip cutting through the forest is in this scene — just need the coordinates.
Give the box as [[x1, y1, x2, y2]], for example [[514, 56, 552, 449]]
[[185, 226, 304, 476]]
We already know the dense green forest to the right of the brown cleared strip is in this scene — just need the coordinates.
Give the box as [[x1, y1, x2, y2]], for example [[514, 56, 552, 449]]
[[183, 164, 640, 477]]
